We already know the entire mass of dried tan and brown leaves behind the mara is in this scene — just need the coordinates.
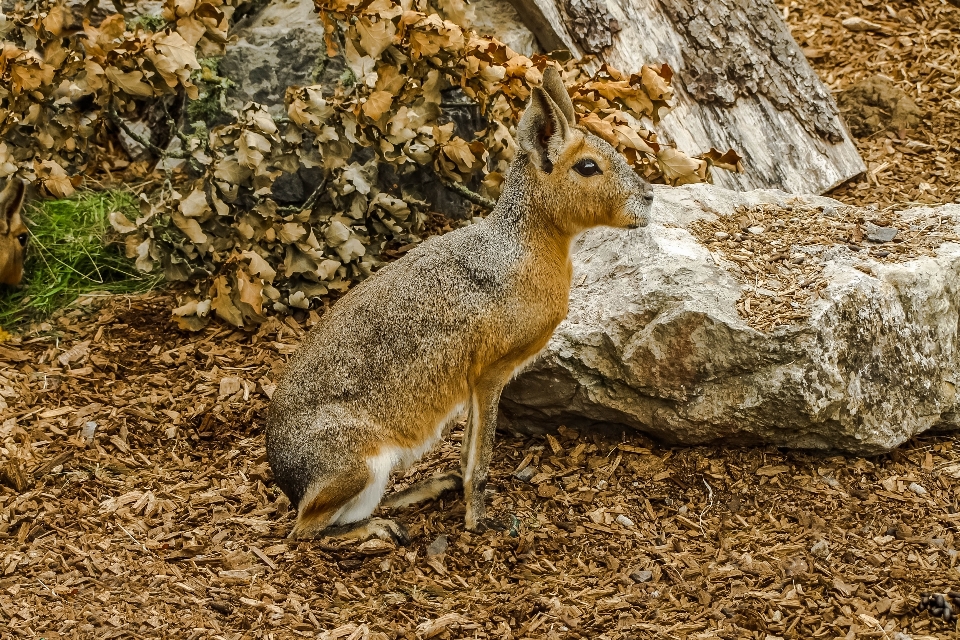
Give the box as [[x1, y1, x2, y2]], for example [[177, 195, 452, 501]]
[[0, 0, 739, 330]]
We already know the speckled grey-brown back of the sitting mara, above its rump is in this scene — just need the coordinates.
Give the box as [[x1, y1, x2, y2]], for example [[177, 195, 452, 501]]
[[277, 219, 521, 415]]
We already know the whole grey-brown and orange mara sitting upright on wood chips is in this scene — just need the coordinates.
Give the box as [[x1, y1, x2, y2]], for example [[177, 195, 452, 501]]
[[267, 68, 653, 538]]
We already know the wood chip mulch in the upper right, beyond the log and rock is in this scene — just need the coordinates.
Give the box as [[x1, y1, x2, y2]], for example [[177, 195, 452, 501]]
[[778, 0, 960, 206]]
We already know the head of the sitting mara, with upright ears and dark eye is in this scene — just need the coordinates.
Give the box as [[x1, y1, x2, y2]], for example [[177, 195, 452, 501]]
[[517, 67, 653, 234]]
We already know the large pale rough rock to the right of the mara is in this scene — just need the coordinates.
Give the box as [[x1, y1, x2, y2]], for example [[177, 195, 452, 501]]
[[501, 185, 960, 453]]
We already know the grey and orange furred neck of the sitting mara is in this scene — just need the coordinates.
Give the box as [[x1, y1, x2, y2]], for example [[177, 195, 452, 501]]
[[487, 156, 577, 263]]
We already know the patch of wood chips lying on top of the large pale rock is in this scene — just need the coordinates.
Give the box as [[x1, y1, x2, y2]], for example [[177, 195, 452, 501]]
[[690, 198, 960, 331]]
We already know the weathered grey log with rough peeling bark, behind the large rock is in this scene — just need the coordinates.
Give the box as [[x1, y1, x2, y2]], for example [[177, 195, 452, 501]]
[[511, 0, 866, 193]]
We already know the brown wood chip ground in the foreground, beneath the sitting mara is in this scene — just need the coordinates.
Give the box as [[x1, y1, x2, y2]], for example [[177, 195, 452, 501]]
[[0, 296, 960, 640]]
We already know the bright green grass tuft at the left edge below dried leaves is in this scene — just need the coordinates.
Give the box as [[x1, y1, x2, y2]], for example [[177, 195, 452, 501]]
[[0, 191, 161, 329]]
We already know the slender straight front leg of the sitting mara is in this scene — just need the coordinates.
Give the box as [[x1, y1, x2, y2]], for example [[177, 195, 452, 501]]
[[460, 376, 504, 531]]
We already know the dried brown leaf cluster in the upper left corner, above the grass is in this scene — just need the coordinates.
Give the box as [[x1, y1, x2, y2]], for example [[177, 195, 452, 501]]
[[0, 0, 232, 197]]
